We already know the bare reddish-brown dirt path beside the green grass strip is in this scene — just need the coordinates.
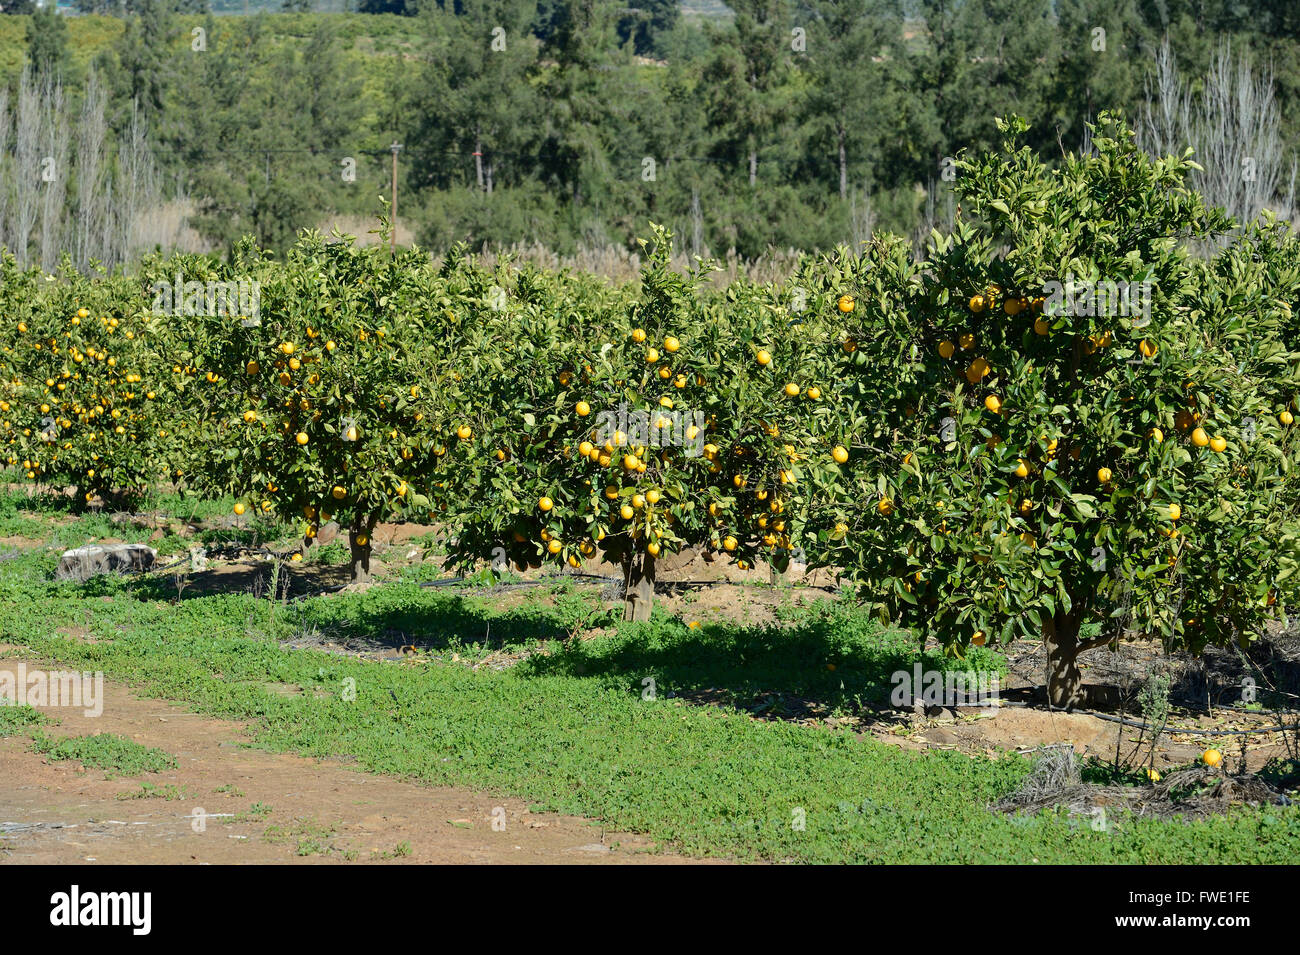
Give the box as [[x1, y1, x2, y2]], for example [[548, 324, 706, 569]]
[[0, 659, 722, 864]]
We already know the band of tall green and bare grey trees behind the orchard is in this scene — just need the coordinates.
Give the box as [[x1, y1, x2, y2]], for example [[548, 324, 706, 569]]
[[0, 0, 1300, 269]]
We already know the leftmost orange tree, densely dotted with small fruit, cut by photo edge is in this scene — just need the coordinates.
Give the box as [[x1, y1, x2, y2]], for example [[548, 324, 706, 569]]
[[0, 255, 173, 504]]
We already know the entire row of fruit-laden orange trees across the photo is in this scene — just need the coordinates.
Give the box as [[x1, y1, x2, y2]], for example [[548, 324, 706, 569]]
[[0, 121, 1300, 706]]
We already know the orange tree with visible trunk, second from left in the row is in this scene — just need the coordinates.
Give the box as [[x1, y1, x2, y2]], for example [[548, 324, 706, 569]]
[[181, 233, 458, 581]]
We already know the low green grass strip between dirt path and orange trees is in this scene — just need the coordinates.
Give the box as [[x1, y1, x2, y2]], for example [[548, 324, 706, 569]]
[[0, 511, 1300, 864]]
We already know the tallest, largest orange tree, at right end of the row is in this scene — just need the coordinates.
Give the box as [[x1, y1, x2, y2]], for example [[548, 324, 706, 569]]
[[807, 117, 1297, 707]]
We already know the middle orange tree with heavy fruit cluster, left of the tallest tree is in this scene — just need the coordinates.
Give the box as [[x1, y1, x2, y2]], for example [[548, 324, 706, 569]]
[[434, 227, 832, 620]]
